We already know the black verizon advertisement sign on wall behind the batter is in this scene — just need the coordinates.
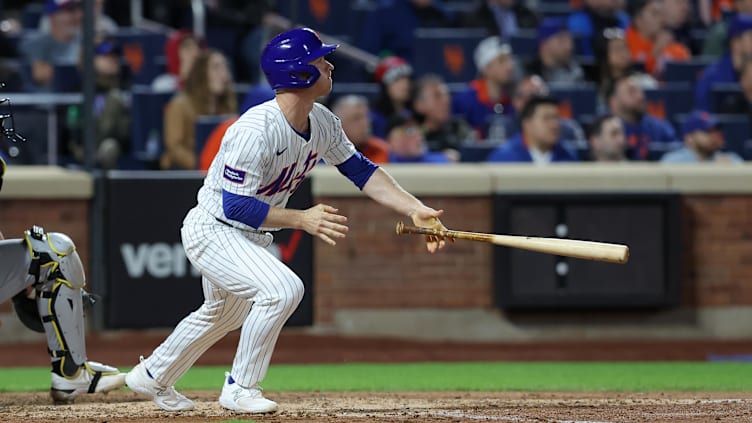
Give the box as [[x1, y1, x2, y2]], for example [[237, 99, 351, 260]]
[[104, 172, 313, 329]]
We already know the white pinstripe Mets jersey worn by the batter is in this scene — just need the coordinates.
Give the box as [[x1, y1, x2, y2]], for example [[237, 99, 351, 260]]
[[198, 99, 355, 230]]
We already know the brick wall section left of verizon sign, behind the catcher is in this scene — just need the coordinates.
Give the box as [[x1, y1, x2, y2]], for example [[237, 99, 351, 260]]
[[0, 199, 90, 313]]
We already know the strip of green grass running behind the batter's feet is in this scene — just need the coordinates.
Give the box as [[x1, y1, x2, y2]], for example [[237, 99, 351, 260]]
[[0, 362, 752, 392]]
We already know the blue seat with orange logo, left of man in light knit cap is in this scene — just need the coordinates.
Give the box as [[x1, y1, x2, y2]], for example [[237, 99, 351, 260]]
[[412, 28, 487, 82]]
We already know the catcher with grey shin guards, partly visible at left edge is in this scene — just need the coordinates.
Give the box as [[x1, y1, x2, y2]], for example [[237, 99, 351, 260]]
[[0, 93, 125, 404]]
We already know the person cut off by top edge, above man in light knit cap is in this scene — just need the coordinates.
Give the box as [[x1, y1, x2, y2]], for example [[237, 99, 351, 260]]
[[462, 0, 540, 41]]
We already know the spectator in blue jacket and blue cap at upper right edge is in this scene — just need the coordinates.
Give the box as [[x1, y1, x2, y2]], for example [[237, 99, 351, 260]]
[[695, 15, 752, 111]]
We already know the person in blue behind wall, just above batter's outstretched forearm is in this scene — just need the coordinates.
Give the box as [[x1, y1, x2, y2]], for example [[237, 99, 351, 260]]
[[387, 115, 451, 163]]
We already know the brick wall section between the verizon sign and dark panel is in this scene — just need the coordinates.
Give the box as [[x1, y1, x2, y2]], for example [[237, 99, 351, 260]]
[[314, 197, 492, 324]]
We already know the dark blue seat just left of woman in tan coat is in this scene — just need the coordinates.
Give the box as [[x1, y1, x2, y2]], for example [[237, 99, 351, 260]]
[[131, 85, 174, 166]]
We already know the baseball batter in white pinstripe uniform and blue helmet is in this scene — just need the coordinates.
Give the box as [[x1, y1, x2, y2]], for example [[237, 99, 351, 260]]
[[126, 28, 444, 413]]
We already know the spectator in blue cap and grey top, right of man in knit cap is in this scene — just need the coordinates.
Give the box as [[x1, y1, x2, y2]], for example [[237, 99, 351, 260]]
[[525, 18, 585, 84]]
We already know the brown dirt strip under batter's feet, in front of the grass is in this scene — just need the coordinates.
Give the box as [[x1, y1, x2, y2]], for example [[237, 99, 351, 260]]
[[0, 390, 752, 423]]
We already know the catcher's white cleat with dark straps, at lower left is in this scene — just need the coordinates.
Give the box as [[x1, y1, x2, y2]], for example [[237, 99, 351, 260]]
[[50, 361, 125, 404]]
